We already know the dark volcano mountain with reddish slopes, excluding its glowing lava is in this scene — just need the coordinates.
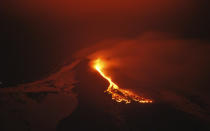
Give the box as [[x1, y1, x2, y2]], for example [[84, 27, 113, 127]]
[[1, 60, 208, 131]]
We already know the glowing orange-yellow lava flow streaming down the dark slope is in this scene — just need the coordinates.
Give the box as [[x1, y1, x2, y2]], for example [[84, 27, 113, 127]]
[[93, 59, 153, 104]]
